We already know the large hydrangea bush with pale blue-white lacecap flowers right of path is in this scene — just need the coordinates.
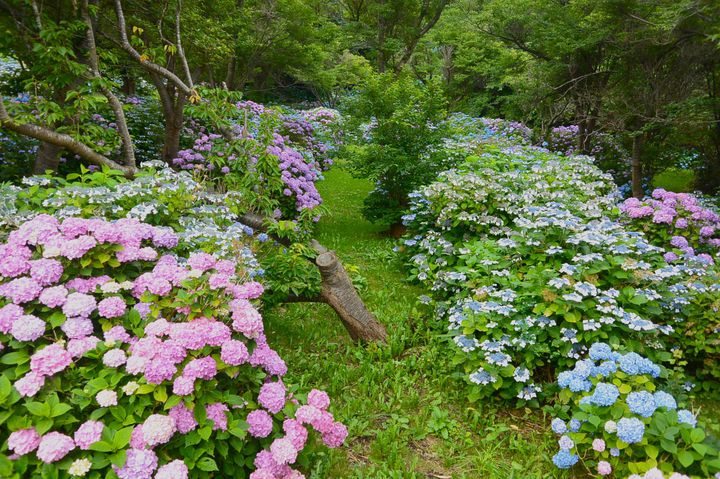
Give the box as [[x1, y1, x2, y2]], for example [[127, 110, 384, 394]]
[[402, 146, 718, 400]]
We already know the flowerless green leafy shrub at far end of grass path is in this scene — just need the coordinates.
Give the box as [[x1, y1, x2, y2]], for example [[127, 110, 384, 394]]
[[342, 75, 448, 229]]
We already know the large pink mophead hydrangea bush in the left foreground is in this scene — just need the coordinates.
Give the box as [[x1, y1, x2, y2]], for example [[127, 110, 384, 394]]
[[0, 215, 347, 479]]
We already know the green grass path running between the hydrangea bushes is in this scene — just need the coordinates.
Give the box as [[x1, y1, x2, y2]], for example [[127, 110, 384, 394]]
[[266, 168, 565, 479]]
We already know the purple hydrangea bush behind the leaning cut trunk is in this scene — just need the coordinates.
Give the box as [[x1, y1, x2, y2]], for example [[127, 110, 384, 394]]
[[173, 101, 331, 221]]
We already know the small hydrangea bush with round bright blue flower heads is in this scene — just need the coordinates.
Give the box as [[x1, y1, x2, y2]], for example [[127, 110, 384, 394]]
[[551, 343, 720, 477]]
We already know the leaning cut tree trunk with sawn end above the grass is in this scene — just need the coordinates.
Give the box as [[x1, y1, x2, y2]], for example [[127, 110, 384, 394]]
[[240, 213, 387, 342]]
